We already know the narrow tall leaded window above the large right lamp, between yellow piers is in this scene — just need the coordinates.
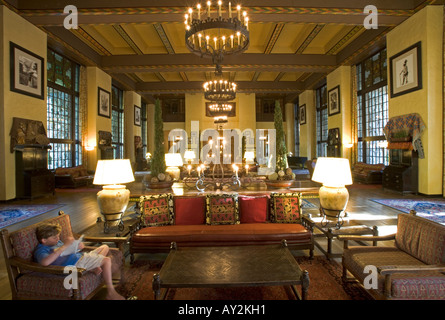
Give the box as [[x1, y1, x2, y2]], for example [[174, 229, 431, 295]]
[[315, 84, 328, 157]]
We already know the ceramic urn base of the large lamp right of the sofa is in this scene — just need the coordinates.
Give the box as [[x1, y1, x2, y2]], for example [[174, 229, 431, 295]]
[[319, 186, 349, 228]]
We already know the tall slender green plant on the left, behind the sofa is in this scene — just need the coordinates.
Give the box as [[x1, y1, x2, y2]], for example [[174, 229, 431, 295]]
[[151, 99, 167, 177]]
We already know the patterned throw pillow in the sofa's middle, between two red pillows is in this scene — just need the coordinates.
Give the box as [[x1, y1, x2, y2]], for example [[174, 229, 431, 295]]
[[206, 193, 239, 224]]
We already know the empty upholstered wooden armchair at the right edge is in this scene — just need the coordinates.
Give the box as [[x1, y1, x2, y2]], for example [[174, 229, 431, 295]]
[[338, 212, 445, 300]]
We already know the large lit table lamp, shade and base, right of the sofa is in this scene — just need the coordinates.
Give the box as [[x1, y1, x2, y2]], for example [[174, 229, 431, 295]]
[[312, 157, 352, 227]]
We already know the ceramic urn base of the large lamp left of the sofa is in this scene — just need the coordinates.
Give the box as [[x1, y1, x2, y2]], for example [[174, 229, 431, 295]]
[[97, 185, 130, 233]]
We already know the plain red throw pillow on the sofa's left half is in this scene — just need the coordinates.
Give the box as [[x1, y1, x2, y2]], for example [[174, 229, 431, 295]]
[[174, 197, 205, 225]]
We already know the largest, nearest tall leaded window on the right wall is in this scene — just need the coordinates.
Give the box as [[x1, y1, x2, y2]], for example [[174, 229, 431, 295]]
[[357, 49, 389, 164]]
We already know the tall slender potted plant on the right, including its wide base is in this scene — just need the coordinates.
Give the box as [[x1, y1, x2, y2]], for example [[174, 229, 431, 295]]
[[266, 100, 295, 188]]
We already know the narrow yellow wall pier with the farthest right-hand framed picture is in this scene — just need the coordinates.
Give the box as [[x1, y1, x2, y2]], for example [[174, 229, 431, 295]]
[[299, 90, 317, 159]]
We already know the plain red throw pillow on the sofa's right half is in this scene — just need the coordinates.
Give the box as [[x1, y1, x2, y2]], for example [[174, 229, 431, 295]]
[[239, 196, 269, 223]]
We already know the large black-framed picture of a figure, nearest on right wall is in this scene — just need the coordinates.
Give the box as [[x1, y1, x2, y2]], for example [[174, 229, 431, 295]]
[[389, 42, 422, 98]]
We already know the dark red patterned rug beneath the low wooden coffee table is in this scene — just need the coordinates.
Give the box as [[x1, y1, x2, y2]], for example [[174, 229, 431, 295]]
[[116, 256, 369, 300]]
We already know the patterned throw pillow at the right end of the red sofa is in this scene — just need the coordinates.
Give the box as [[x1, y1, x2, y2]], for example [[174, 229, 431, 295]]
[[270, 192, 301, 223]]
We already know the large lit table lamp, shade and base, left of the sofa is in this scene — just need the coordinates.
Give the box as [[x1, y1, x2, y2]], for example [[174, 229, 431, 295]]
[[93, 159, 134, 233]]
